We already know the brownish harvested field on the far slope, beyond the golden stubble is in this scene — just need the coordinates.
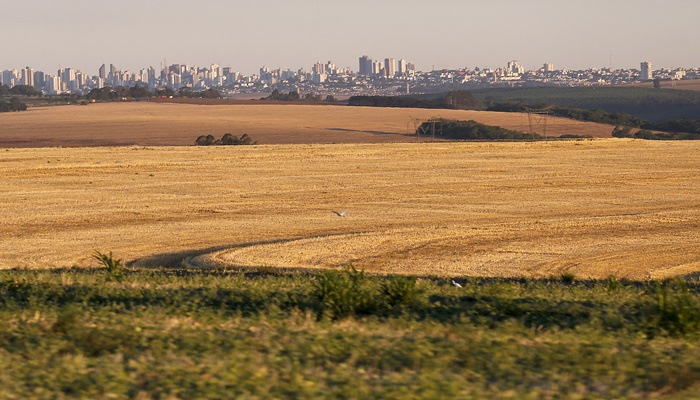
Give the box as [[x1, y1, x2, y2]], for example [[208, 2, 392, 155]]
[[0, 102, 613, 147]]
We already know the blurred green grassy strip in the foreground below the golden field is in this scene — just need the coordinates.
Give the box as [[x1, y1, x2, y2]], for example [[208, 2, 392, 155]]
[[0, 269, 700, 399]]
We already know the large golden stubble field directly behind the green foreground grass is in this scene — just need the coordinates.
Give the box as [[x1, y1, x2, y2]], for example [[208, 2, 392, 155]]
[[0, 139, 700, 279]]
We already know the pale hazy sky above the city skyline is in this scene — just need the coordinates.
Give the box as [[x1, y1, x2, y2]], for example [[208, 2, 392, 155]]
[[0, 0, 700, 75]]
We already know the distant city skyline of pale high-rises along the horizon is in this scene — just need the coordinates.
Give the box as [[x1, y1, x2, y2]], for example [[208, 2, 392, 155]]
[[0, 55, 700, 97]]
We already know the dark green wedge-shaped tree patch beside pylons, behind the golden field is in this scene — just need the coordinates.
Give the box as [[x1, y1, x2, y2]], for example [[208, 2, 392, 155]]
[[416, 119, 543, 140]]
